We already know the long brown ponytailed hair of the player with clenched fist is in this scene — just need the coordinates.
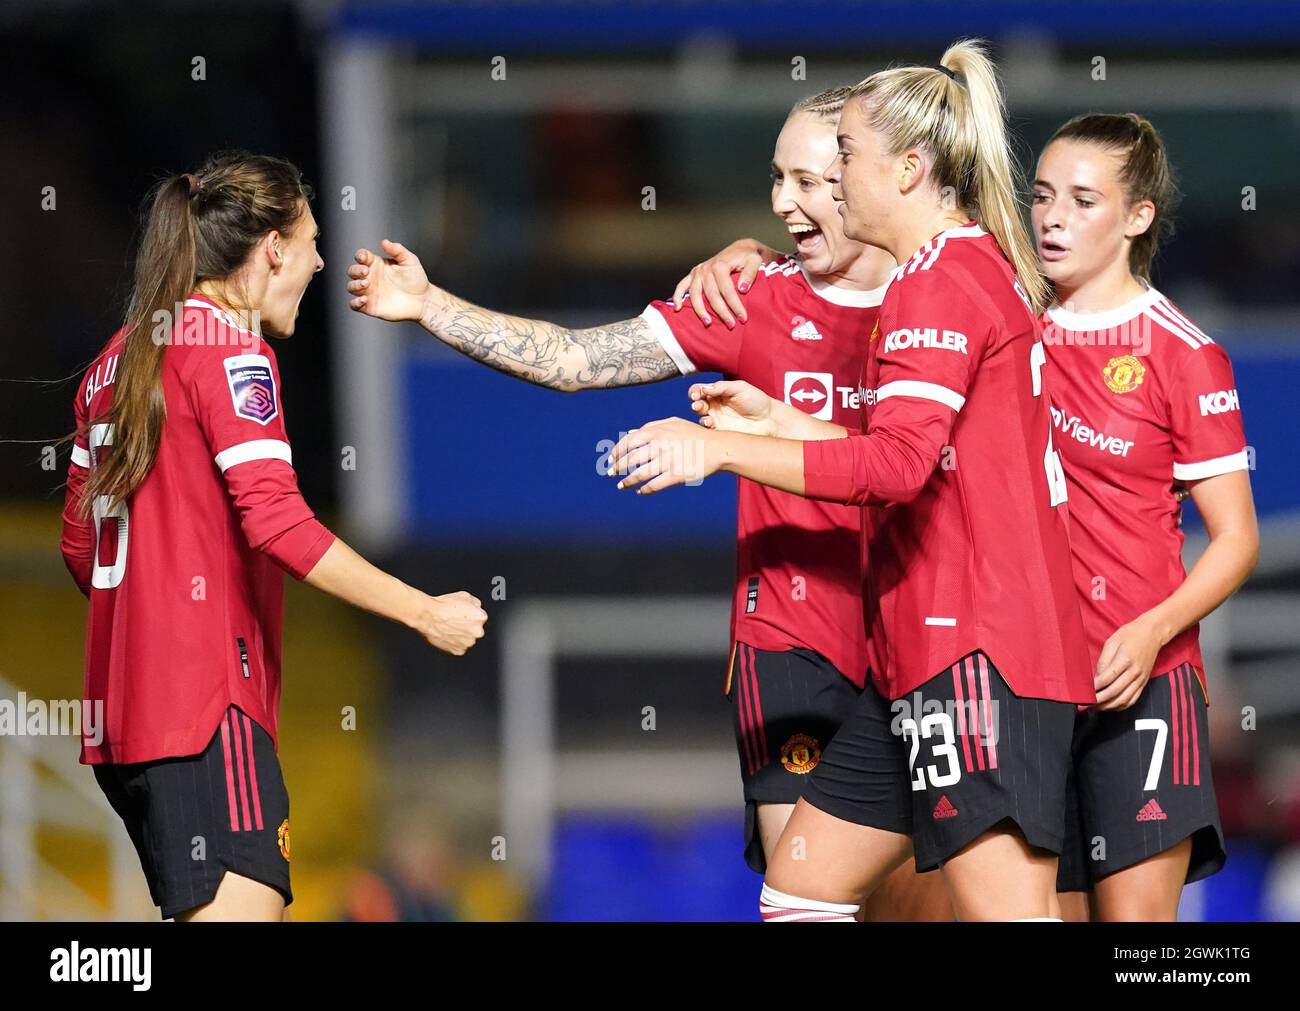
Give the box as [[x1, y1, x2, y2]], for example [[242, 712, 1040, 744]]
[[81, 151, 311, 513]]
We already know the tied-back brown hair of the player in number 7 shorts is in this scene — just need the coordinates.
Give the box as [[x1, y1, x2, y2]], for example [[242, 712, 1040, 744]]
[[1048, 112, 1179, 282]]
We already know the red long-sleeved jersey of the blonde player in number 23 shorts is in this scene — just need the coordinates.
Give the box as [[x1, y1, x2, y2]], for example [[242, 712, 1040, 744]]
[[803, 224, 1096, 703]]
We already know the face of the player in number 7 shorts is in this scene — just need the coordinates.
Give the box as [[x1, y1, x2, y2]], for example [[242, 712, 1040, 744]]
[[1034, 139, 1154, 294]]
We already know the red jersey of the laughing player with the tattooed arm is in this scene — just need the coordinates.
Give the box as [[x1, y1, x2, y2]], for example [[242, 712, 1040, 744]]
[[642, 256, 884, 687]]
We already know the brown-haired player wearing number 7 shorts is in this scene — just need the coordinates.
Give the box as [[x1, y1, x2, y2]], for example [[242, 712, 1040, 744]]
[[1034, 113, 1258, 920]]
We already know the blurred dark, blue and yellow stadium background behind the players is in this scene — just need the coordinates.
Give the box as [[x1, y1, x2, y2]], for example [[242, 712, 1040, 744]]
[[0, 0, 1300, 920]]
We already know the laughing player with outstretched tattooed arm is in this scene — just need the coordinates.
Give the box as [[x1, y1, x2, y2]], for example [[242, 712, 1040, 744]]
[[348, 88, 950, 919]]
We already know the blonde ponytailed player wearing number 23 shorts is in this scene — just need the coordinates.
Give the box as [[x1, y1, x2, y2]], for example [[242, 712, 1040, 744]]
[[611, 42, 1096, 920]]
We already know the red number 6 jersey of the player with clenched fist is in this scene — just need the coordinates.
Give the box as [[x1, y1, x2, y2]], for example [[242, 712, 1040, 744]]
[[62, 295, 334, 764]]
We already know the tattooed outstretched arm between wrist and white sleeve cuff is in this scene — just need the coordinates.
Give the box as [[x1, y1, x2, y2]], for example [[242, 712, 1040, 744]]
[[420, 292, 679, 392]]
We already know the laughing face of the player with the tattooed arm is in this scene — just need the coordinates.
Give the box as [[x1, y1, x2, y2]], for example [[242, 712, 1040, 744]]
[[772, 112, 862, 275]]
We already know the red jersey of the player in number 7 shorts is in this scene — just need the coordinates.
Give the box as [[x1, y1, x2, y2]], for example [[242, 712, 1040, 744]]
[[1043, 288, 1249, 678]]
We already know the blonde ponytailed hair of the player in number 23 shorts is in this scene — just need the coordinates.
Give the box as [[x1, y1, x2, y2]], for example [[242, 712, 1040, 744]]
[[852, 39, 1049, 312]]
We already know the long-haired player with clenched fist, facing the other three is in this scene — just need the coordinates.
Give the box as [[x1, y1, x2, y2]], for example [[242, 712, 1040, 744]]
[[62, 152, 488, 920]]
